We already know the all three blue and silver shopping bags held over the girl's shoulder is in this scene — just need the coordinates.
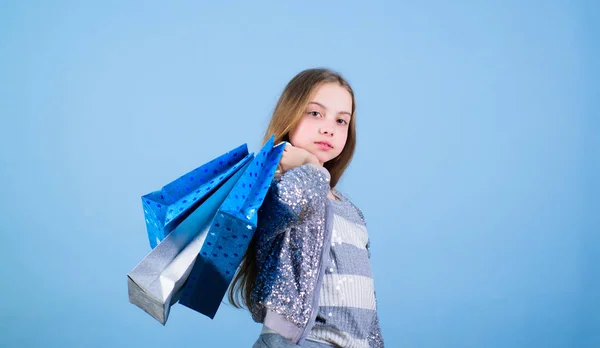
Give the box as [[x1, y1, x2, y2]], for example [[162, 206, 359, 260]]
[[127, 136, 285, 325]]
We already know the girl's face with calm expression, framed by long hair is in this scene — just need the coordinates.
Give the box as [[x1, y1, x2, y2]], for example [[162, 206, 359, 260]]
[[289, 83, 352, 165]]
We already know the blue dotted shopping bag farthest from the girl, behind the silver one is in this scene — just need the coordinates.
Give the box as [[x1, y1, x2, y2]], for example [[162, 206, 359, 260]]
[[142, 144, 254, 249]]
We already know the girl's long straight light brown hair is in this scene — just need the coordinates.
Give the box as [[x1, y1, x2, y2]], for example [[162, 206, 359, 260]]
[[228, 69, 356, 308]]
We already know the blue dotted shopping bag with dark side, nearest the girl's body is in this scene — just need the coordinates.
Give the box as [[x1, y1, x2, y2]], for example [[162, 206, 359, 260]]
[[179, 136, 285, 319]]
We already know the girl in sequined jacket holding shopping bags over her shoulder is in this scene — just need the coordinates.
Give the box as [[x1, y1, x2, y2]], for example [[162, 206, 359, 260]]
[[229, 69, 383, 348]]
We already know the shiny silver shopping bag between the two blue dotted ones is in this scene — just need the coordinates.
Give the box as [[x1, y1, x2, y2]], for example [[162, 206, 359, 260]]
[[127, 146, 254, 325]]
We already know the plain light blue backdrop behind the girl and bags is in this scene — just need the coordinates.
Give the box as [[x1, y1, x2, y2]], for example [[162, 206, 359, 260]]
[[0, 1, 600, 347]]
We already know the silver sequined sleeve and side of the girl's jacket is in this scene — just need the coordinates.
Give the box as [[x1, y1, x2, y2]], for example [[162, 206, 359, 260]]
[[250, 164, 330, 327]]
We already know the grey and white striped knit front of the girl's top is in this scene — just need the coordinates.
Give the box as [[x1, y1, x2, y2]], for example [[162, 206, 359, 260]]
[[308, 198, 377, 348]]
